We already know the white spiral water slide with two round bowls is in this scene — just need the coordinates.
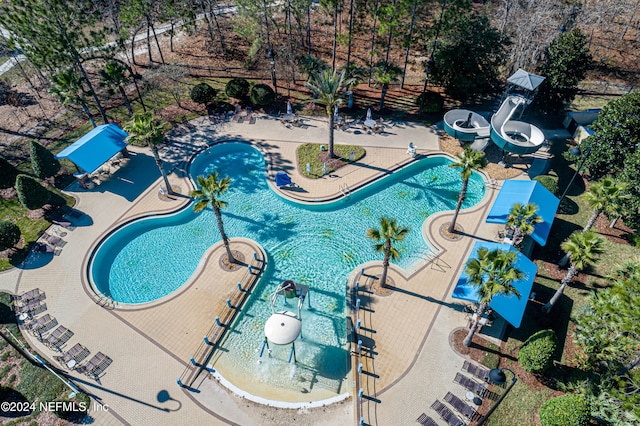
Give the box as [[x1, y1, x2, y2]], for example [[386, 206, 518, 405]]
[[444, 95, 544, 155]]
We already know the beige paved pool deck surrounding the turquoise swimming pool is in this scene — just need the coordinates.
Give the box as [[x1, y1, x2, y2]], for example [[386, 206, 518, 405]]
[[0, 116, 520, 425]]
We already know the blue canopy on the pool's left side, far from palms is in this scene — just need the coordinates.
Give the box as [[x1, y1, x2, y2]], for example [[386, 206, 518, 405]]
[[56, 123, 129, 174]]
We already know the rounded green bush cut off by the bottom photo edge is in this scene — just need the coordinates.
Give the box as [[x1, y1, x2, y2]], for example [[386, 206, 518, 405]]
[[539, 394, 591, 426]]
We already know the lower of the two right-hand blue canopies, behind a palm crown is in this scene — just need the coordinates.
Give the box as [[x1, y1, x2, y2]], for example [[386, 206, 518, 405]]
[[451, 241, 538, 328]]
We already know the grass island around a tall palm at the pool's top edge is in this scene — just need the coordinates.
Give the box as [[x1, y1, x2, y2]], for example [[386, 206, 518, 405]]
[[297, 143, 366, 179]]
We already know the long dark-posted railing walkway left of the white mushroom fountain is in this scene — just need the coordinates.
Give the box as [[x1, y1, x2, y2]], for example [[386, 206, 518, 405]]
[[177, 252, 265, 387]]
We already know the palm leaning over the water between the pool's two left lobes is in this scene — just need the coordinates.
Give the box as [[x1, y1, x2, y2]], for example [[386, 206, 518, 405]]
[[191, 172, 236, 263]]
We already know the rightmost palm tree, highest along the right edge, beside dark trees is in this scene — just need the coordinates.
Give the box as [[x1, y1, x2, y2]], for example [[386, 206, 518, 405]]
[[583, 176, 629, 231]]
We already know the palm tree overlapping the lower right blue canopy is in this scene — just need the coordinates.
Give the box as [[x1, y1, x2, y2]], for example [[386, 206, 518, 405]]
[[463, 247, 524, 347]]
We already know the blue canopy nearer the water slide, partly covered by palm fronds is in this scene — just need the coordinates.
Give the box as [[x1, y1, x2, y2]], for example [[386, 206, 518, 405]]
[[487, 180, 560, 246]]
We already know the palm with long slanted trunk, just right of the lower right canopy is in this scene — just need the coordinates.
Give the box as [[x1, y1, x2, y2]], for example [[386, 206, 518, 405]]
[[542, 231, 604, 313]]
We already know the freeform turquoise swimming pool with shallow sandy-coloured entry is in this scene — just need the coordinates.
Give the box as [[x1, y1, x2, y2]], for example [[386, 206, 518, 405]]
[[86, 143, 485, 401]]
